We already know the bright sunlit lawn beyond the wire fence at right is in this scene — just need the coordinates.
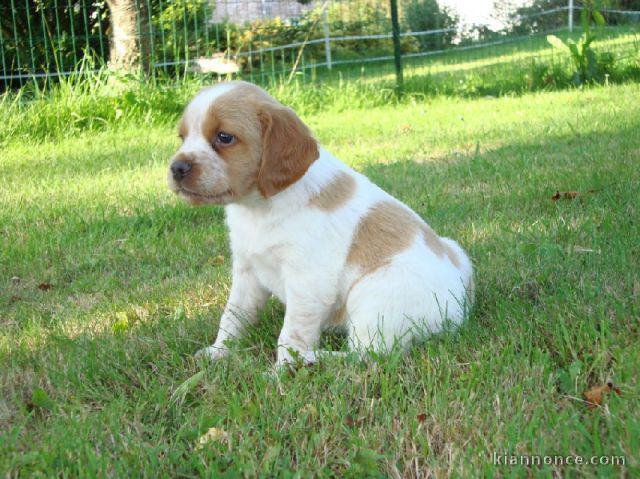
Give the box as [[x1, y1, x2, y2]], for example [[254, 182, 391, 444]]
[[284, 25, 640, 94]]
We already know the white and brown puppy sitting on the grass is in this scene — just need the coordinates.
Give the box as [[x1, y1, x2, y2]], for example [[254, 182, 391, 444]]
[[169, 82, 473, 365]]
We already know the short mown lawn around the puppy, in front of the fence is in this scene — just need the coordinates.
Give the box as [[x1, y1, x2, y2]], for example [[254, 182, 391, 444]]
[[0, 85, 640, 478]]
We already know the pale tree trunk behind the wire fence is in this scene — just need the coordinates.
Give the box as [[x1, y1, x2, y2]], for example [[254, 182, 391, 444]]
[[107, 0, 150, 72]]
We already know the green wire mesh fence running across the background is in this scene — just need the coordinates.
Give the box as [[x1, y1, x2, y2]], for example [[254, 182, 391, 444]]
[[0, 0, 640, 90]]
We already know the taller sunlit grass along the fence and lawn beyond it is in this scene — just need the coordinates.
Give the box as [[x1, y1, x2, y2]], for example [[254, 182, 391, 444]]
[[0, 26, 640, 145]]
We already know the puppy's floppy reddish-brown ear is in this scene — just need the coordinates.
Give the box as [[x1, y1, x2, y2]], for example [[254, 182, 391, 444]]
[[258, 103, 320, 198]]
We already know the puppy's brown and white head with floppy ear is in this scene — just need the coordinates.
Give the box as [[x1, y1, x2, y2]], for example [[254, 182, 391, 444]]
[[168, 82, 319, 204]]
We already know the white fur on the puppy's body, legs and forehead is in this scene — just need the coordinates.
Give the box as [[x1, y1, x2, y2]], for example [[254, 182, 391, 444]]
[[185, 86, 472, 364]]
